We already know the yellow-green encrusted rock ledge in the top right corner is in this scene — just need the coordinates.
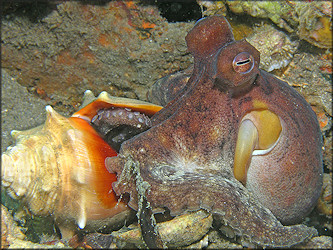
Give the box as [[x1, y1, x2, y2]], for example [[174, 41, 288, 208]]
[[198, 0, 332, 48]]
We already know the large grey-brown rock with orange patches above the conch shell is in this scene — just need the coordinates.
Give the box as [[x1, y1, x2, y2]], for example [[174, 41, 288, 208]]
[[1, 1, 193, 111]]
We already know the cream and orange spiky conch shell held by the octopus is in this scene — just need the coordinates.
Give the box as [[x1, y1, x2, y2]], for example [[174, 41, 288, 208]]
[[1, 91, 162, 235]]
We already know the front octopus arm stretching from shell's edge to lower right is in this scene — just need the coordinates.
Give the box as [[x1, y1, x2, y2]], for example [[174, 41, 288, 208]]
[[107, 155, 317, 247]]
